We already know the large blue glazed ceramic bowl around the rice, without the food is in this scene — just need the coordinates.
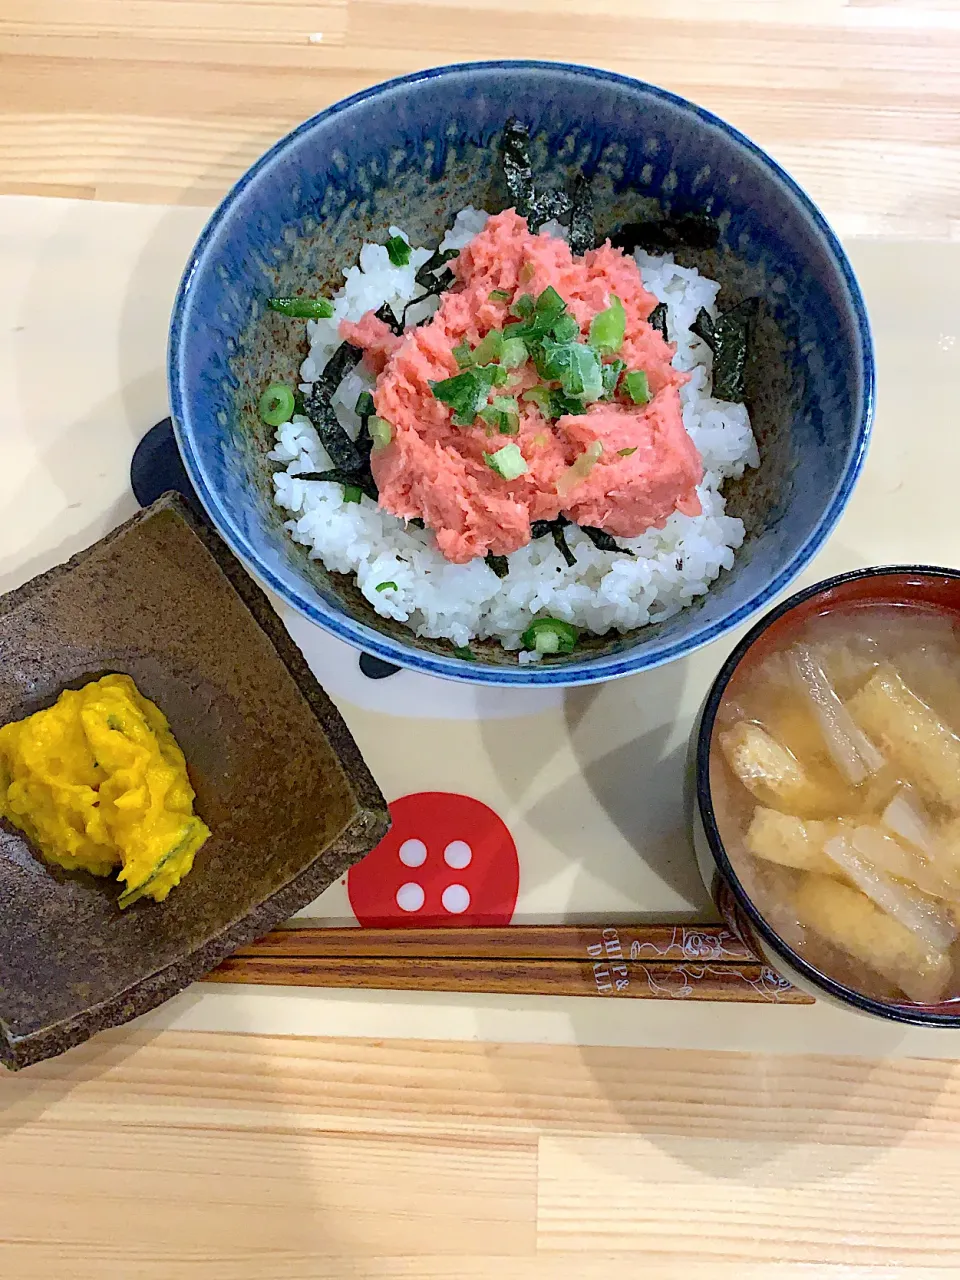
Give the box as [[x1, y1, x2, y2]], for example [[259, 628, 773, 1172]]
[[169, 61, 874, 685]]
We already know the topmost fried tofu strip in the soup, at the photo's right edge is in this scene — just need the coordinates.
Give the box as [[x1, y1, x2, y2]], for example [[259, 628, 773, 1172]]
[[847, 666, 960, 810]]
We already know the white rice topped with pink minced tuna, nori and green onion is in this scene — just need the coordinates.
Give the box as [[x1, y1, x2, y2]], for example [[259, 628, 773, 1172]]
[[261, 124, 759, 663]]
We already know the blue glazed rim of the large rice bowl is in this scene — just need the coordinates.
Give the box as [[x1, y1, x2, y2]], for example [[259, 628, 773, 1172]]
[[168, 59, 877, 687]]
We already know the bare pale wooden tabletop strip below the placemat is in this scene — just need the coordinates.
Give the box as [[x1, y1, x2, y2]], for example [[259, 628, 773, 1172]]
[[0, 1030, 960, 1280]]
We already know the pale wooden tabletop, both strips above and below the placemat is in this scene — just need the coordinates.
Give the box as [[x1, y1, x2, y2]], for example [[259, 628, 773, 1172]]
[[0, 0, 960, 1280]]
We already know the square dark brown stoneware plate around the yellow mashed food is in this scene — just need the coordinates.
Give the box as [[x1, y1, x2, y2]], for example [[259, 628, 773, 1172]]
[[0, 494, 389, 1068]]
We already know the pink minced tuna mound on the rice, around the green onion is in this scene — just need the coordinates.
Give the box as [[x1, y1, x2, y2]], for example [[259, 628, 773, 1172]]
[[340, 210, 703, 563]]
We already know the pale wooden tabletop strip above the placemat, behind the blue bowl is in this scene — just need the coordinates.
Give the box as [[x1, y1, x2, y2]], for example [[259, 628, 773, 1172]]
[[0, 0, 960, 239]]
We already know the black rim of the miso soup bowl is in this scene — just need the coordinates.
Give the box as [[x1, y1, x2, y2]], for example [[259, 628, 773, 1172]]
[[695, 564, 960, 1028]]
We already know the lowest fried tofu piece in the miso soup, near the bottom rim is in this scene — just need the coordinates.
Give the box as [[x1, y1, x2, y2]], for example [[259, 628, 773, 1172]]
[[794, 874, 952, 1005]]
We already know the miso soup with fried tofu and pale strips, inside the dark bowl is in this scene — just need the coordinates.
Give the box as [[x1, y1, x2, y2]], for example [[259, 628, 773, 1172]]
[[710, 604, 960, 1005]]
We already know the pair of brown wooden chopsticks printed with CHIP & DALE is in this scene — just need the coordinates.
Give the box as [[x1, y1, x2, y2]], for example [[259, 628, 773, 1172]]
[[207, 924, 813, 1005]]
